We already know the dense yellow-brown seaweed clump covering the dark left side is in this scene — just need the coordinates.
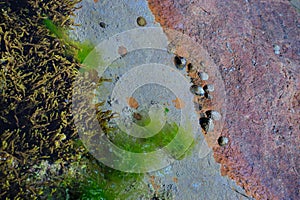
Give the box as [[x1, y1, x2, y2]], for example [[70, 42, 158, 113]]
[[0, 0, 101, 199]]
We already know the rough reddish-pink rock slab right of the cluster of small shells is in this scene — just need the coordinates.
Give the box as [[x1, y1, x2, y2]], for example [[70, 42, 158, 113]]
[[149, 0, 300, 199]]
